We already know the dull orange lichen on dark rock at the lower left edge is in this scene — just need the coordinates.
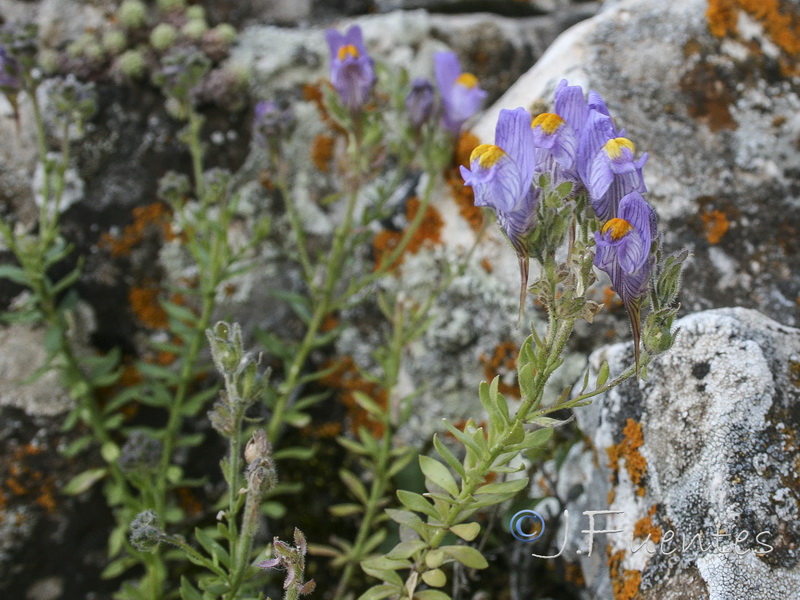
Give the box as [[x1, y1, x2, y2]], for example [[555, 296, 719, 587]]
[[0, 444, 56, 513]]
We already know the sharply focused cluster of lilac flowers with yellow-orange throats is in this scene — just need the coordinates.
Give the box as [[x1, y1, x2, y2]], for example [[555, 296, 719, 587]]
[[461, 81, 657, 352]]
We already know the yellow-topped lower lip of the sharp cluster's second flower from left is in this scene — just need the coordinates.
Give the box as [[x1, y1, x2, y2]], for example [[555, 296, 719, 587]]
[[531, 113, 578, 186]]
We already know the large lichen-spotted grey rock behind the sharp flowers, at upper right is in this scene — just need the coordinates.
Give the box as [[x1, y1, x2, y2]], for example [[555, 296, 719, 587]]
[[475, 0, 800, 325]]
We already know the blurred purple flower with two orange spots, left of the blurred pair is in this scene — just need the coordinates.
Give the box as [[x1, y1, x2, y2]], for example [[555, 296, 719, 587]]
[[325, 25, 376, 110]]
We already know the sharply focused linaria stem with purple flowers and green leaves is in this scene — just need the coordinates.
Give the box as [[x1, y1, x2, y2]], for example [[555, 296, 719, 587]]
[[360, 82, 686, 600]]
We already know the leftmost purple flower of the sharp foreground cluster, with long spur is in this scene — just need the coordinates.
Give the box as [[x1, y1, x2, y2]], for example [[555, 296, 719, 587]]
[[461, 108, 541, 317]]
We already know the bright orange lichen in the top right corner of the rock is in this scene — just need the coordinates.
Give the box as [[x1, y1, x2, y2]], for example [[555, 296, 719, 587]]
[[706, 0, 800, 75]]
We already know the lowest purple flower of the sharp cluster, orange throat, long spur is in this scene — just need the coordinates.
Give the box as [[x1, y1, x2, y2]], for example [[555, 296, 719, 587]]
[[594, 192, 657, 368]]
